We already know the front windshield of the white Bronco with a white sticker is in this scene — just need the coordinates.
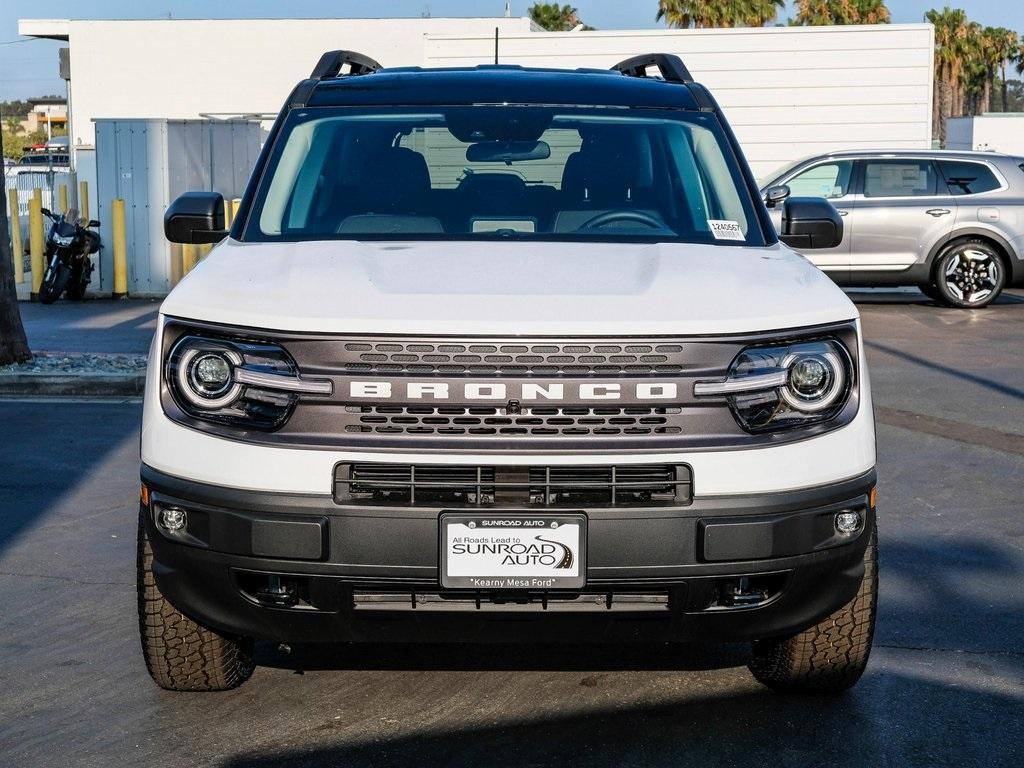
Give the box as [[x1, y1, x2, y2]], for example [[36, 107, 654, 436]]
[[244, 106, 764, 245]]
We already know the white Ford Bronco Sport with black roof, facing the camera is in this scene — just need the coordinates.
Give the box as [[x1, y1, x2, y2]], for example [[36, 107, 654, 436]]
[[138, 51, 878, 691]]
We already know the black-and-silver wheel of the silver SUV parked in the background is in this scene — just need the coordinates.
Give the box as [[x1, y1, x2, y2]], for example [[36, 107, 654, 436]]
[[934, 240, 1007, 309]]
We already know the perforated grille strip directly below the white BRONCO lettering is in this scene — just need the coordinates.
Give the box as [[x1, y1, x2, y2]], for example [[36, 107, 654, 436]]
[[345, 406, 682, 437]]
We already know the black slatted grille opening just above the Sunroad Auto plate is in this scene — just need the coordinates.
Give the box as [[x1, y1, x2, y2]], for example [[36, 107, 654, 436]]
[[335, 463, 693, 507]]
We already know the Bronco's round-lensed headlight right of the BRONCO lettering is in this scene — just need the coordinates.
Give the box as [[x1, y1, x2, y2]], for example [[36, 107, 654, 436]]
[[693, 339, 853, 432]]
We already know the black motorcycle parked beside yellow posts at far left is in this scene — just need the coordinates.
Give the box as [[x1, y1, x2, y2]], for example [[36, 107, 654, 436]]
[[39, 208, 99, 304]]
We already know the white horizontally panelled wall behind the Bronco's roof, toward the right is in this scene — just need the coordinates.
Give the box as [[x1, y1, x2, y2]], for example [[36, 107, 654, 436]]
[[426, 25, 934, 182]]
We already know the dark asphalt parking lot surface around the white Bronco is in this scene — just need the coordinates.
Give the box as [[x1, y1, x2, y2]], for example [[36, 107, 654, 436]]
[[0, 291, 1024, 768]]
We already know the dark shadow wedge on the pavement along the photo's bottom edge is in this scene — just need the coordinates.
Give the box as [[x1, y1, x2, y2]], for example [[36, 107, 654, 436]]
[[221, 675, 1022, 768]]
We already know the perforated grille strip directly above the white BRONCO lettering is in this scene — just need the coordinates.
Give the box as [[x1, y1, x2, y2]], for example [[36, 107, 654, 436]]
[[343, 340, 684, 376]]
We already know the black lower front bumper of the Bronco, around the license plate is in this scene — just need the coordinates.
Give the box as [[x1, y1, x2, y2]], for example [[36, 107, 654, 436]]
[[142, 467, 874, 642]]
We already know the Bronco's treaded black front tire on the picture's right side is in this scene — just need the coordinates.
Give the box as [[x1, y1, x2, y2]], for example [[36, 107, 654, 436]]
[[748, 525, 879, 693]]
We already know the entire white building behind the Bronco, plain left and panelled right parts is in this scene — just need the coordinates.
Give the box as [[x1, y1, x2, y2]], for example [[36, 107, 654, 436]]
[[18, 18, 934, 182]]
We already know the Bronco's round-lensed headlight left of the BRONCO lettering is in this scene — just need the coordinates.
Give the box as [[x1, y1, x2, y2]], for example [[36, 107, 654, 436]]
[[164, 336, 333, 429]]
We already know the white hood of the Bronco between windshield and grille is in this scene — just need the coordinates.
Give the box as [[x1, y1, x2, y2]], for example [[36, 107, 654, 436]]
[[162, 241, 857, 336]]
